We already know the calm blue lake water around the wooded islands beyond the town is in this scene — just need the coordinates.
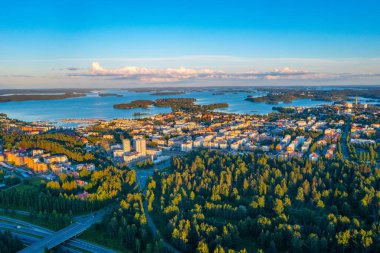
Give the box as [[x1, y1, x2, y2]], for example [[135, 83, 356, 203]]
[[0, 90, 354, 124]]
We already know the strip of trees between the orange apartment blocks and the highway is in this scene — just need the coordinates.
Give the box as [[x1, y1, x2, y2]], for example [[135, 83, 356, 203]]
[[0, 167, 137, 229]]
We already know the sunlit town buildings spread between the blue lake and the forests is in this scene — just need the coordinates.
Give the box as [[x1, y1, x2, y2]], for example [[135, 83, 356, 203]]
[[0, 100, 380, 191]]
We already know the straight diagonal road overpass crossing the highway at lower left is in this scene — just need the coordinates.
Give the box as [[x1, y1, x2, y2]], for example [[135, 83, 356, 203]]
[[19, 212, 111, 253]]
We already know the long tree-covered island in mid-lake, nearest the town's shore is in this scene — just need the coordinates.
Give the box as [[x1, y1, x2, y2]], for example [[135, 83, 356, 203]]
[[113, 98, 228, 112]]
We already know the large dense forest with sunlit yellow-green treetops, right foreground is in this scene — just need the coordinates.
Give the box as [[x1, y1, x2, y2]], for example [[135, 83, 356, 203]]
[[147, 151, 380, 252]]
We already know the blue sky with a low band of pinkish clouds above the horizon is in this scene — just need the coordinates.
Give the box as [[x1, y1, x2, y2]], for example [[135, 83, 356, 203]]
[[0, 0, 380, 88]]
